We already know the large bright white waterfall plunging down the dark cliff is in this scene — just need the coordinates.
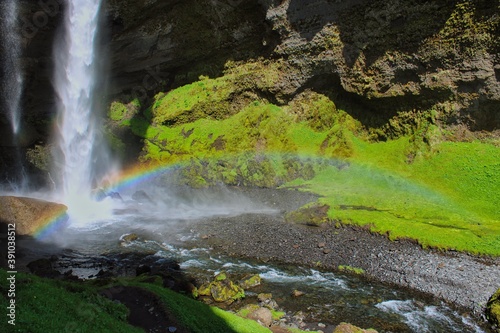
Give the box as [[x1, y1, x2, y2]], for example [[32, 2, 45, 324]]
[[54, 0, 106, 209]]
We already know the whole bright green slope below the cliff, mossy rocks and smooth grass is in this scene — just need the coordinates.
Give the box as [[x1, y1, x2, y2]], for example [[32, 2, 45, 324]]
[[110, 63, 500, 255]]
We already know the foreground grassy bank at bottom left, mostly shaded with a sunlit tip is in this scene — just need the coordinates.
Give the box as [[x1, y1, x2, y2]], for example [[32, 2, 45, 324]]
[[0, 269, 270, 333]]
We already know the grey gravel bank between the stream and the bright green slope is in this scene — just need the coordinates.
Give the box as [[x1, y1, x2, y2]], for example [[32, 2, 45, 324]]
[[187, 189, 500, 316]]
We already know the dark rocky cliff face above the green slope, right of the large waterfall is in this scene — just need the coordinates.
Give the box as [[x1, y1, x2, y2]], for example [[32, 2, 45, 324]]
[[106, 0, 500, 134]]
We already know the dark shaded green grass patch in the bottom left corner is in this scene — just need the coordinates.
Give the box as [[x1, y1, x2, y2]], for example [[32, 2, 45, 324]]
[[0, 269, 142, 333]]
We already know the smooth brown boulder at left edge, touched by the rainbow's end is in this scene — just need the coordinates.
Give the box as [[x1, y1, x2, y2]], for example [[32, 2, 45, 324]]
[[0, 196, 68, 236]]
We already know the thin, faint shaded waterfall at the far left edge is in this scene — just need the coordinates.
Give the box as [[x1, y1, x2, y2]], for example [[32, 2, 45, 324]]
[[0, 0, 23, 135]]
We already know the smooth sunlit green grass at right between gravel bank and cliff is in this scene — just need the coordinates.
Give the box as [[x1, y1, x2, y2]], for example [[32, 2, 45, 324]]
[[287, 139, 500, 256]]
